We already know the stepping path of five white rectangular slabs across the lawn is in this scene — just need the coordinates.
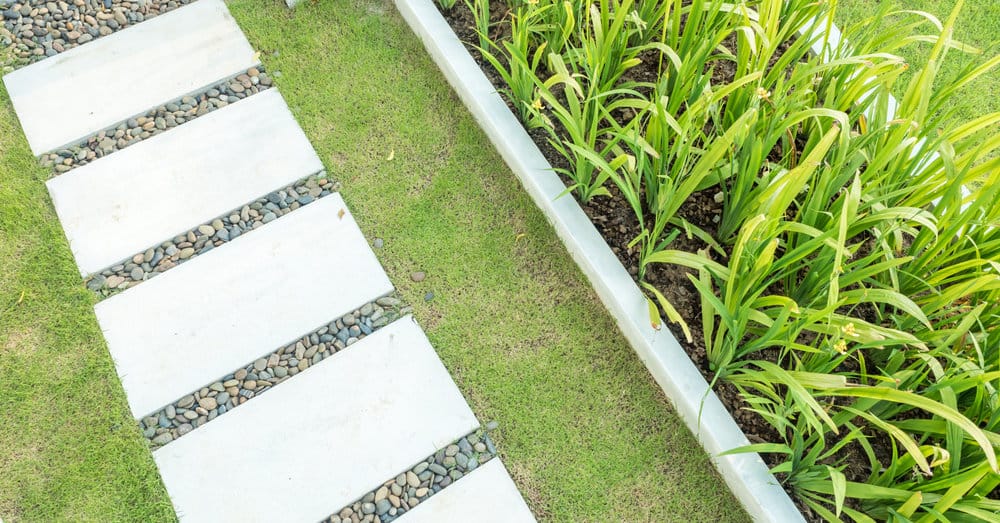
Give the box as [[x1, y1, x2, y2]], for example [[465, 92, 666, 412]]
[[4, 0, 534, 523]]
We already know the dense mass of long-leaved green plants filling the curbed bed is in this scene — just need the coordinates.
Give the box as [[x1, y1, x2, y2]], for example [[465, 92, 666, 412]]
[[481, 0, 1000, 522]]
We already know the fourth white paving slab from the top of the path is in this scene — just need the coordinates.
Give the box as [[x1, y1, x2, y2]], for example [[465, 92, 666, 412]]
[[153, 316, 479, 522]]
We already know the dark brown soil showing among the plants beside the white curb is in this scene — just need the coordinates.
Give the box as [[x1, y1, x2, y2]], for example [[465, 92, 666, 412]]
[[441, 3, 868, 521]]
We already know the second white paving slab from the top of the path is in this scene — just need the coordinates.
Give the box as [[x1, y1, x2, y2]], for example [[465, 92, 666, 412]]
[[47, 90, 323, 275]]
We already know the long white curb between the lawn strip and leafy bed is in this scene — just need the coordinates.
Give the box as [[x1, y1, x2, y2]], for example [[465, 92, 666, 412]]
[[394, 0, 804, 522]]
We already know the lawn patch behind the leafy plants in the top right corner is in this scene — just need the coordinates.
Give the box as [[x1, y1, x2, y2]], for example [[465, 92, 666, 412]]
[[838, 0, 1000, 122]]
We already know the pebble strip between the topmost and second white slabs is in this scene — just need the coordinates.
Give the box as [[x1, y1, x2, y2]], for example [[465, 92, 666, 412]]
[[40, 66, 273, 171]]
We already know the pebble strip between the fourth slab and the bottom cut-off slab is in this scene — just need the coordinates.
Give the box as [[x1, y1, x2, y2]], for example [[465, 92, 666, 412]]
[[323, 428, 497, 523]]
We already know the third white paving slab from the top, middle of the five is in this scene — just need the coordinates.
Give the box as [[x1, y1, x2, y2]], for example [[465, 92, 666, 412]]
[[94, 194, 392, 418]]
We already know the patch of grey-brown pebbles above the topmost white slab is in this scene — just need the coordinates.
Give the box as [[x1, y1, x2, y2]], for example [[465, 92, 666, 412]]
[[0, 0, 193, 72]]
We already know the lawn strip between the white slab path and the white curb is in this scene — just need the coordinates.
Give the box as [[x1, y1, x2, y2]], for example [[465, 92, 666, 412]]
[[229, 0, 747, 522]]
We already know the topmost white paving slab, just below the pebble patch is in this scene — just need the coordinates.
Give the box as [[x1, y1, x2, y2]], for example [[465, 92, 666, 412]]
[[4, 0, 258, 155]]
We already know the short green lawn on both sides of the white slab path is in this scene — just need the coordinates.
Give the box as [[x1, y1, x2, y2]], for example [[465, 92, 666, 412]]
[[0, 0, 747, 523]]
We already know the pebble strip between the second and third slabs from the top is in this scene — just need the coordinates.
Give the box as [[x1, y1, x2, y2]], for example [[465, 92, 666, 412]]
[[86, 172, 339, 299]]
